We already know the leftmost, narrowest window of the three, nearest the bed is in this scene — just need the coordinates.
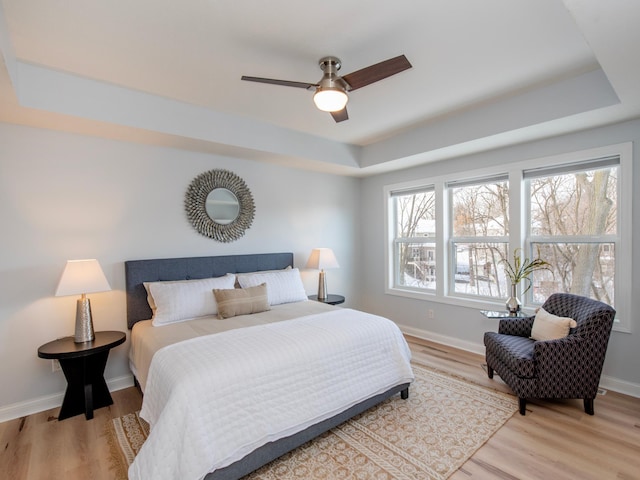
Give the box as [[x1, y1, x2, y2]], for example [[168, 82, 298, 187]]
[[390, 187, 436, 291]]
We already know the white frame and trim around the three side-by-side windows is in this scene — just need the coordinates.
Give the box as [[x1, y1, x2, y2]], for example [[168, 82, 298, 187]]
[[383, 142, 633, 333]]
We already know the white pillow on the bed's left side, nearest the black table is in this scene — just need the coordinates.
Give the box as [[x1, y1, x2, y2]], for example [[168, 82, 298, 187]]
[[145, 275, 235, 327]]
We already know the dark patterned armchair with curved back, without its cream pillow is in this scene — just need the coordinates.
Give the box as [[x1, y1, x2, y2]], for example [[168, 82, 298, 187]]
[[484, 293, 616, 415]]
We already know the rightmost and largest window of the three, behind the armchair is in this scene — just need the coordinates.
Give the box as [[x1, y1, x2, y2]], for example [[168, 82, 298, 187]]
[[524, 156, 620, 305]]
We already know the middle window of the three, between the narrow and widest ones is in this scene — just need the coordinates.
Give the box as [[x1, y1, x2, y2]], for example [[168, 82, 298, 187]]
[[447, 175, 509, 299]]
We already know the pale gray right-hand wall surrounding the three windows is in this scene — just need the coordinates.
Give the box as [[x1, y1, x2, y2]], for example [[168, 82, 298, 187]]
[[360, 121, 640, 396]]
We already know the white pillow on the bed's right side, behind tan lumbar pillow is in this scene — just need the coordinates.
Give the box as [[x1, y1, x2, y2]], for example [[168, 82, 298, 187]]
[[238, 268, 308, 305]]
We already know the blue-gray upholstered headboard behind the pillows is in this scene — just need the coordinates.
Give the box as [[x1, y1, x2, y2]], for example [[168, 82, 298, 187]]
[[124, 253, 293, 328]]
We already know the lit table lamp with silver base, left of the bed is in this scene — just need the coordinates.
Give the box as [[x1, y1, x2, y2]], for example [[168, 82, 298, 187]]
[[56, 259, 111, 343]]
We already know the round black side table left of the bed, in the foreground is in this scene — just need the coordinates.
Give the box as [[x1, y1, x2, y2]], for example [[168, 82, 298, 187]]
[[38, 331, 127, 420]]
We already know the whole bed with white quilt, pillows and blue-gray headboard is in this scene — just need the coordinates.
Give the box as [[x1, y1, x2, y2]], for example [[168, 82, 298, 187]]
[[125, 253, 413, 480]]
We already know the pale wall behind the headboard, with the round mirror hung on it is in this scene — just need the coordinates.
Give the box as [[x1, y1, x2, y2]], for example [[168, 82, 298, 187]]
[[0, 123, 360, 421]]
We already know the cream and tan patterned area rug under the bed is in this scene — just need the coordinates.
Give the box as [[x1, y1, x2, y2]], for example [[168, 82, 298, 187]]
[[107, 364, 518, 480]]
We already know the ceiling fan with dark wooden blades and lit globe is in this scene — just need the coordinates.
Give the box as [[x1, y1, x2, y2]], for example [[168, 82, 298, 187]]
[[241, 55, 411, 122]]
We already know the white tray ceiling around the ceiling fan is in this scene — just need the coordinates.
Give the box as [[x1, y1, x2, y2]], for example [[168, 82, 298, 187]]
[[0, 0, 640, 175]]
